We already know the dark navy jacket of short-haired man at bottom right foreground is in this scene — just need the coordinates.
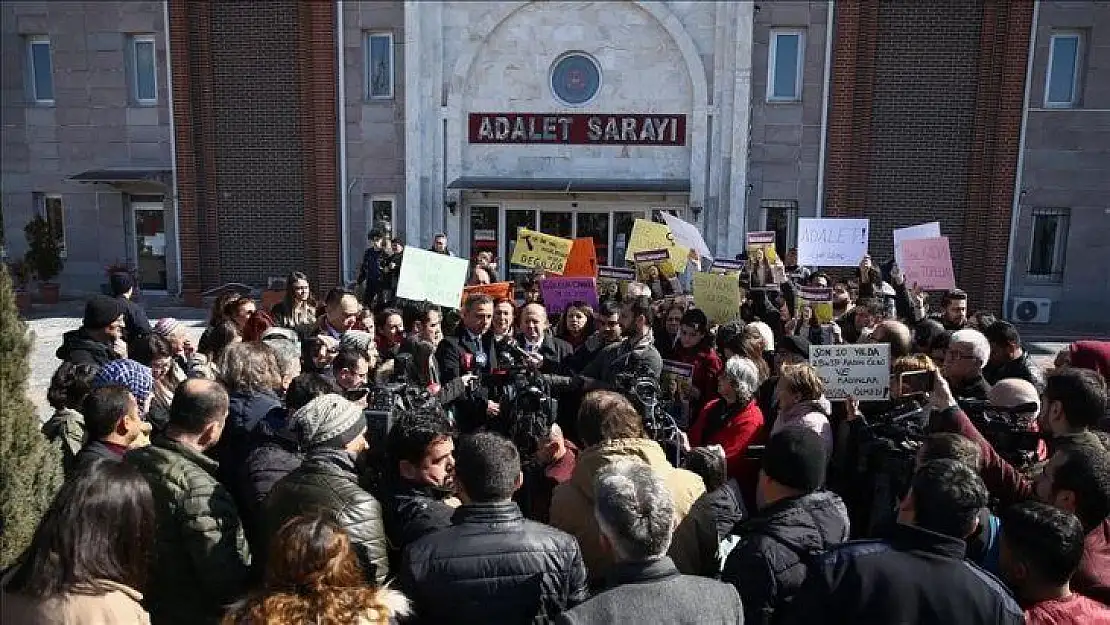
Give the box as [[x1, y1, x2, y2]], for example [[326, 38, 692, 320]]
[[781, 524, 1025, 625]]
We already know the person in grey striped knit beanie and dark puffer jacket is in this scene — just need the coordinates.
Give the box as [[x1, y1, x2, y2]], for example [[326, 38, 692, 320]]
[[262, 395, 390, 584]]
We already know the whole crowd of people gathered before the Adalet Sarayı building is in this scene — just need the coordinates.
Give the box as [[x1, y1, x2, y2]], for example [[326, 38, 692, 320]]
[[0, 229, 1110, 625]]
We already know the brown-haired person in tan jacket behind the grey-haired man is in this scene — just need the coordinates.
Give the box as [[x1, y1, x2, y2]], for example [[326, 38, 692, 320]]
[[551, 391, 705, 585]]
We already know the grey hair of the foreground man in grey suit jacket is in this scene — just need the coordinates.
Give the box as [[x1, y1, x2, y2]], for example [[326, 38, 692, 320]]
[[594, 461, 675, 562]]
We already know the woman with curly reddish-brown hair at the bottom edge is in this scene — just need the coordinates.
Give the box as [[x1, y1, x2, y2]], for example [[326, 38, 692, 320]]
[[223, 515, 410, 625]]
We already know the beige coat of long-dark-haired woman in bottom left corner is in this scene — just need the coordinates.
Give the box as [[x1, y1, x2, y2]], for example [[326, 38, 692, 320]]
[[0, 582, 150, 625]]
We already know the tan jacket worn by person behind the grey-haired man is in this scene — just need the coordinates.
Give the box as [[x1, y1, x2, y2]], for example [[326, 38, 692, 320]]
[[551, 438, 705, 583]]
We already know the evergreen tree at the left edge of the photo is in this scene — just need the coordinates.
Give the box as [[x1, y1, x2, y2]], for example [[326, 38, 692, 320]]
[[0, 263, 62, 568]]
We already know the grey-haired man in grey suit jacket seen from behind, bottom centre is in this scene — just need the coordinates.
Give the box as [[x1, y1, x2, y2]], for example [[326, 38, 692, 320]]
[[558, 461, 744, 625]]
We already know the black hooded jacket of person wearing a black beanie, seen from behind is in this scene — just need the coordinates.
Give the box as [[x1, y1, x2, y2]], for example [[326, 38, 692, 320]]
[[722, 491, 848, 625]]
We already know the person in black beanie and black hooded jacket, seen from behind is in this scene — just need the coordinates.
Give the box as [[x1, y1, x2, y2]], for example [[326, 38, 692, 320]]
[[722, 427, 849, 623]]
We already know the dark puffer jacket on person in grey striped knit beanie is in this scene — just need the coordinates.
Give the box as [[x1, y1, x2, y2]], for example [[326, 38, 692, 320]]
[[261, 448, 390, 584]]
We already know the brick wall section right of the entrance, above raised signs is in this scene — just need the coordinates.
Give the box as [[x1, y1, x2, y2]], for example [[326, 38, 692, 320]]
[[826, 0, 1031, 311]]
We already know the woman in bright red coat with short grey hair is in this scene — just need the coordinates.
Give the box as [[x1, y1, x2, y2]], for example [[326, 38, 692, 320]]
[[688, 356, 764, 510]]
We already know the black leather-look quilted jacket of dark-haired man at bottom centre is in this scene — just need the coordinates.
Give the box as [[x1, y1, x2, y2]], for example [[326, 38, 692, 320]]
[[401, 502, 587, 625]]
